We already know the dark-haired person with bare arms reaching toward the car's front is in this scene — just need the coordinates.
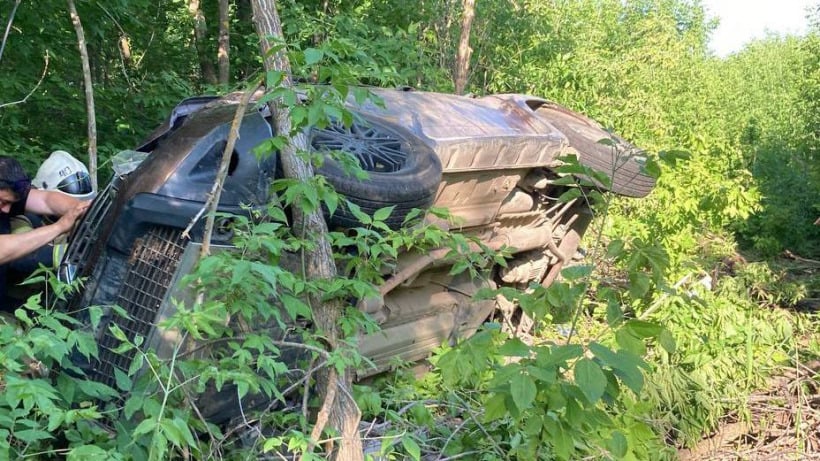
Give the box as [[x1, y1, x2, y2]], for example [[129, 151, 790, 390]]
[[0, 156, 90, 311]]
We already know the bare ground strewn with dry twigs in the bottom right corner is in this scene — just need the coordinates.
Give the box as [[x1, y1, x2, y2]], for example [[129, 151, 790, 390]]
[[679, 361, 820, 461]]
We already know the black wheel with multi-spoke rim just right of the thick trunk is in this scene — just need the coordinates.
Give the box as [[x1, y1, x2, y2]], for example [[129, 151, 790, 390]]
[[311, 120, 441, 229]]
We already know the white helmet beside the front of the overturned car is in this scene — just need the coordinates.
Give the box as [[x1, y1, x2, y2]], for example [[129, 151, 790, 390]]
[[31, 150, 97, 200]]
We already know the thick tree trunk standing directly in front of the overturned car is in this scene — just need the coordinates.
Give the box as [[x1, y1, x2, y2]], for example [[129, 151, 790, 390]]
[[251, 0, 363, 461]]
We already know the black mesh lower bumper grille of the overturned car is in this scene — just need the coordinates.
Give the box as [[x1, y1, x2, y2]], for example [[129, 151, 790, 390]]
[[90, 227, 184, 387]]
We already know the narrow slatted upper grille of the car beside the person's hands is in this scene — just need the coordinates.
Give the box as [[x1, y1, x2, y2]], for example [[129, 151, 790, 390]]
[[60, 181, 117, 282]]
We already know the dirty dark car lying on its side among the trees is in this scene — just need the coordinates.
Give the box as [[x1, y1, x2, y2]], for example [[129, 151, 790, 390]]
[[63, 85, 654, 416]]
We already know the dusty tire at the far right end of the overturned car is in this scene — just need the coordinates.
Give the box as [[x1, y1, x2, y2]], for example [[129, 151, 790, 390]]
[[535, 103, 655, 197]]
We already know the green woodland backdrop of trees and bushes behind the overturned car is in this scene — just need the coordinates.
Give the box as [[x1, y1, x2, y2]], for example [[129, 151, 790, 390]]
[[0, 0, 820, 459]]
